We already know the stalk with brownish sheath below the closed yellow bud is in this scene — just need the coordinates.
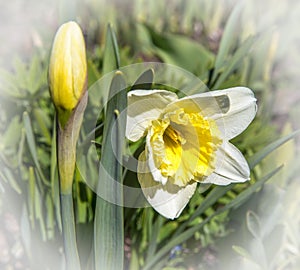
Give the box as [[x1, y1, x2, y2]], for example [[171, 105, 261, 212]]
[[57, 92, 88, 270]]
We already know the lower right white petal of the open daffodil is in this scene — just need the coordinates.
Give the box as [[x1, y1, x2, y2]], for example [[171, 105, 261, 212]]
[[202, 142, 250, 185]]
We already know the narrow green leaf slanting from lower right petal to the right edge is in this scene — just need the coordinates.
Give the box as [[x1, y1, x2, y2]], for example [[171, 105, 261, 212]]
[[248, 129, 300, 169]]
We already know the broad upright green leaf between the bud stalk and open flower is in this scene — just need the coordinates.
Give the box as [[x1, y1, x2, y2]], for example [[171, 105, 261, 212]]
[[94, 71, 127, 270]]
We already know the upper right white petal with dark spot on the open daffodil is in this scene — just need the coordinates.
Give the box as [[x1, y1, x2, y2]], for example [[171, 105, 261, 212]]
[[167, 87, 257, 140]]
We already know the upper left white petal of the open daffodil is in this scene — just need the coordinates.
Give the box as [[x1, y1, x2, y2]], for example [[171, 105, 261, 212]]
[[126, 90, 178, 141]]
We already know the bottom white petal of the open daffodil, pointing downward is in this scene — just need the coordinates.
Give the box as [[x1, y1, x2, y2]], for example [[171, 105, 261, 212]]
[[138, 152, 197, 219]]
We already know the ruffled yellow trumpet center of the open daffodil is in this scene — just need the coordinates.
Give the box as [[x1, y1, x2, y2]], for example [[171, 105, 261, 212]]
[[150, 109, 221, 186]]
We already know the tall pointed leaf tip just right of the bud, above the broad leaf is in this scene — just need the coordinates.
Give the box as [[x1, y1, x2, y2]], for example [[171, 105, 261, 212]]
[[103, 24, 120, 74]]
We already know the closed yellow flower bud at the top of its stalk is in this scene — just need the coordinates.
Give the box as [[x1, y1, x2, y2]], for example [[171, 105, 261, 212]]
[[49, 21, 87, 112]]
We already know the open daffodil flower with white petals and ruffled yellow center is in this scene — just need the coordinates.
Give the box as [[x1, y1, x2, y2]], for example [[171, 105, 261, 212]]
[[126, 87, 257, 219]]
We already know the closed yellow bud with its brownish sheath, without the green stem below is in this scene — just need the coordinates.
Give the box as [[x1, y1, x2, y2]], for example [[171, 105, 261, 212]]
[[48, 21, 88, 193]]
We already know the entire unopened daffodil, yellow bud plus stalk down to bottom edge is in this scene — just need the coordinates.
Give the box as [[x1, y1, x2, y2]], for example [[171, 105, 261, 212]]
[[48, 21, 88, 270]]
